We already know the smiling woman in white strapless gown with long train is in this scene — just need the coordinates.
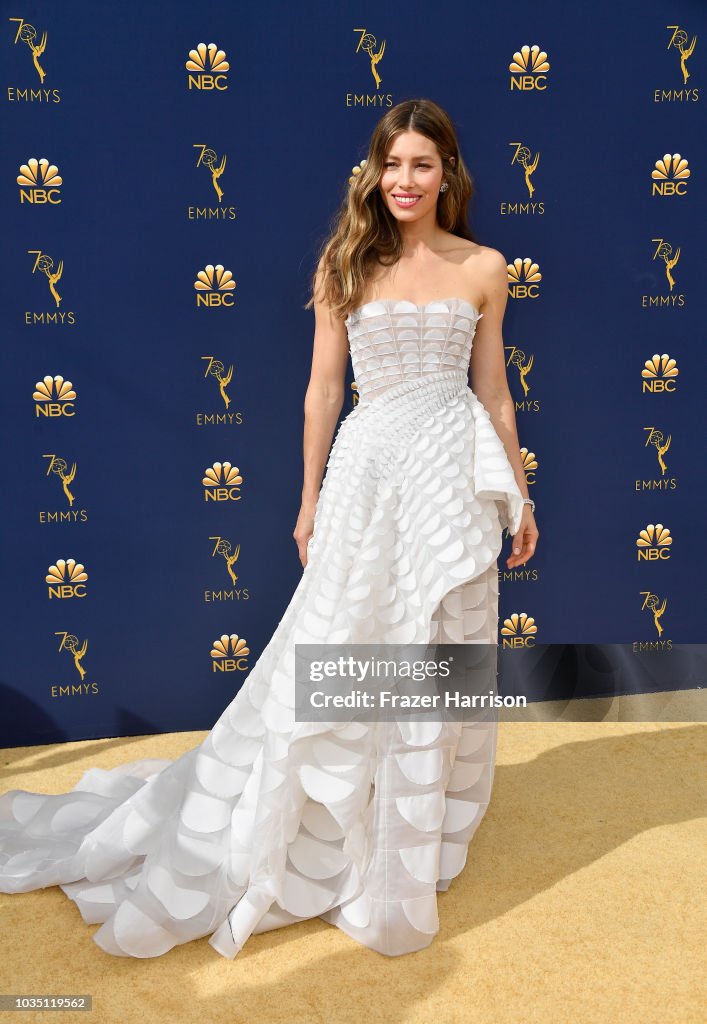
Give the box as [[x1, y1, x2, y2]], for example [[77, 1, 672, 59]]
[[0, 100, 538, 957]]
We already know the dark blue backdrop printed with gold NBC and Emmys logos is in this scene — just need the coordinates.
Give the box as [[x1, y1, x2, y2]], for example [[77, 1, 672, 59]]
[[0, 0, 707, 746]]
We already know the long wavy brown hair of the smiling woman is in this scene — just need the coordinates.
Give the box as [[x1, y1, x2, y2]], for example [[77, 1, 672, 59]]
[[304, 99, 476, 317]]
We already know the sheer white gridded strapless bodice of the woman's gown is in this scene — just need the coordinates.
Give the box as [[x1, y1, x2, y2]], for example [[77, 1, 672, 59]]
[[345, 298, 484, 398]]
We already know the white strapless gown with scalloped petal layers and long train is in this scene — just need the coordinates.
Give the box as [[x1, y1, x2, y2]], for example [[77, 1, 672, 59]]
[[0, 298, 523, 957]]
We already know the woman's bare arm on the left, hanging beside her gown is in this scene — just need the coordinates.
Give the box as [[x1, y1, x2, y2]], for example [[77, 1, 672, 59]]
[[292, 265, 348, 567]]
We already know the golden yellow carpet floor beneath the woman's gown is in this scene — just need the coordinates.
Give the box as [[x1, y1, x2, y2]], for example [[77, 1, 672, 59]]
[[0, 721, 707, 1024]]
